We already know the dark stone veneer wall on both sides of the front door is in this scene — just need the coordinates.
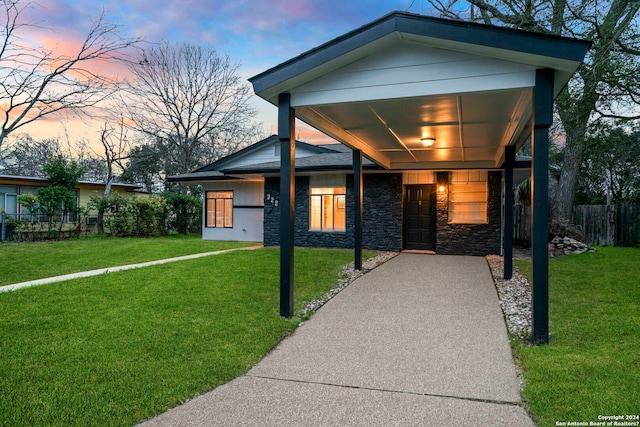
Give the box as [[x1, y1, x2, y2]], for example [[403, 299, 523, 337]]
[[264, 172, 502, 256]]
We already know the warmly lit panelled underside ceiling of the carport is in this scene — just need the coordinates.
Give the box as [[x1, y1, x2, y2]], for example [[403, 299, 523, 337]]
[[298, 90, 531, 169]]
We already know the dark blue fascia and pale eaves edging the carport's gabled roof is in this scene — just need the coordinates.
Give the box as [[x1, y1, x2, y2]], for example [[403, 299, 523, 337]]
[[249, 12, 590, 105]]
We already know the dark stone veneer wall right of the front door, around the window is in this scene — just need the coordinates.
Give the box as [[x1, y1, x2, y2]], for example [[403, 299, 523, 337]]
[[436, 171, 502, 256]]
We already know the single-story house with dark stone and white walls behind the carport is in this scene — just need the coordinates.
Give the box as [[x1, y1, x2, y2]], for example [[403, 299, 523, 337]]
[[169, 135, 529, 255]]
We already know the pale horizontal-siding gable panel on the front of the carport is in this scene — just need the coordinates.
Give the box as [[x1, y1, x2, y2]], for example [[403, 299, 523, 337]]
[[291, 39, 535, 107]]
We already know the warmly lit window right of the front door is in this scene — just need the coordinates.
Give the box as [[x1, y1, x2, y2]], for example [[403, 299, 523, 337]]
[[449, 171, 489, 224]]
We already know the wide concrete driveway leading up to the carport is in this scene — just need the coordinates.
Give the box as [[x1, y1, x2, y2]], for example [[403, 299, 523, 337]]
[[143, 254, 533, 427]]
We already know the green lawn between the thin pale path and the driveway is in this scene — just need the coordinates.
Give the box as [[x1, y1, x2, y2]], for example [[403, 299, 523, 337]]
[[0, 246, 373, 426]]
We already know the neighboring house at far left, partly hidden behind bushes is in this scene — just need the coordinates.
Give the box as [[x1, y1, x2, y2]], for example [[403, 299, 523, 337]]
[[0, 175, 144, 231]]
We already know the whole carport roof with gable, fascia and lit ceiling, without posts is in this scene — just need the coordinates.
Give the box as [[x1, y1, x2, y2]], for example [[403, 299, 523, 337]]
[[250, 12, 589, 169]]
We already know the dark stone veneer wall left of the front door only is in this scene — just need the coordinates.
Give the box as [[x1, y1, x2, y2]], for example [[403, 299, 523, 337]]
[[264, 174, 402, 251]]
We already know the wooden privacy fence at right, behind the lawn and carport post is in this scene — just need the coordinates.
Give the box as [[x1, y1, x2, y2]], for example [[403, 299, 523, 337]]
[[513, 202, 640, 246]]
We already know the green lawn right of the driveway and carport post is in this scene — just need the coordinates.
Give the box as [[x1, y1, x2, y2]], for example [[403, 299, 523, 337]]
[[514, 247, 640, 426]]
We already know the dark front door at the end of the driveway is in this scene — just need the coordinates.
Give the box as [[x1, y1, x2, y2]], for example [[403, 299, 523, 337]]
[[404, 185, 436, 251]]
